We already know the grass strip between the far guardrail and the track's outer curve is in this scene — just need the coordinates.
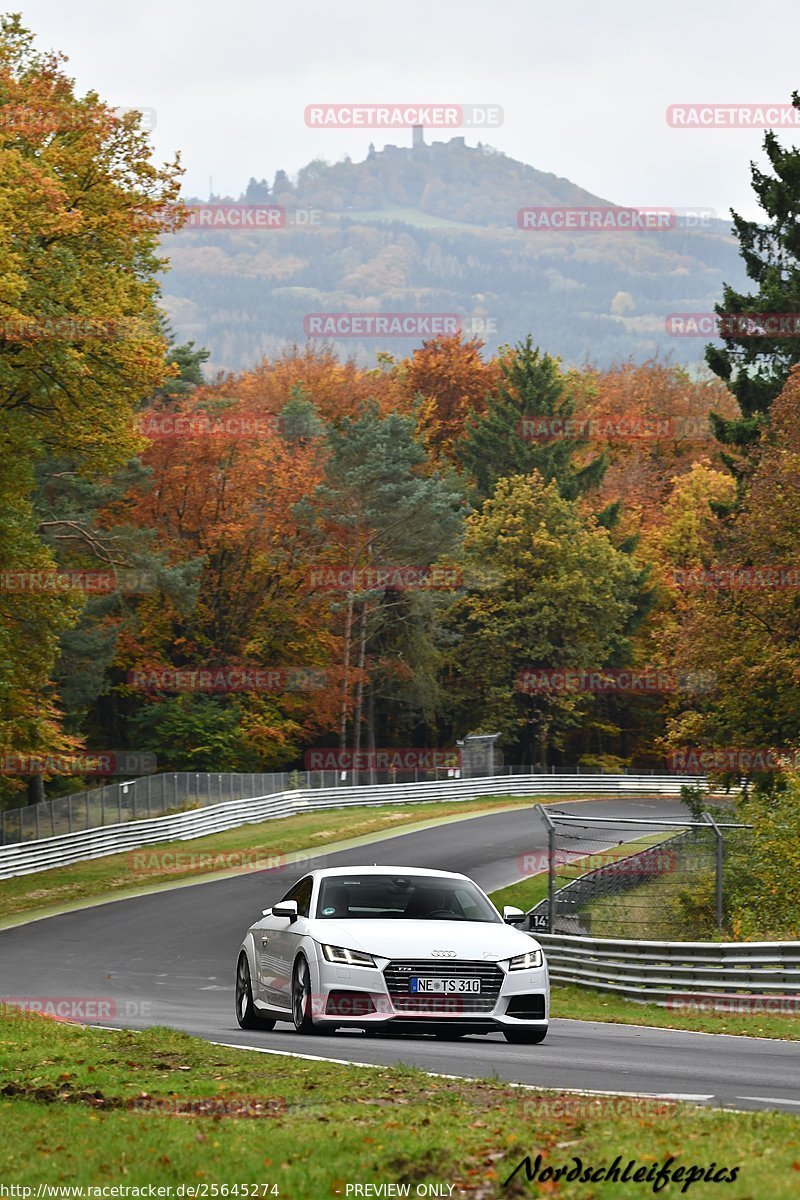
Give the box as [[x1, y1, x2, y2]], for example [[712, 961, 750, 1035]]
[[0, 797, 547, 928]]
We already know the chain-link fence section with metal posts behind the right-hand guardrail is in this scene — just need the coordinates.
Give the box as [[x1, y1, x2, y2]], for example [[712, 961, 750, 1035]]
[[529, 809, 748, 941]]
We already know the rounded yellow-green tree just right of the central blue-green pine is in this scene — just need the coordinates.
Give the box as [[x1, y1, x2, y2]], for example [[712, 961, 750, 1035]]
[[447, 470, 643, 763]]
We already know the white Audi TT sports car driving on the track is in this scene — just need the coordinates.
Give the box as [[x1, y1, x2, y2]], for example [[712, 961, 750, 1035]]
[[236, 866, 549, 1042]]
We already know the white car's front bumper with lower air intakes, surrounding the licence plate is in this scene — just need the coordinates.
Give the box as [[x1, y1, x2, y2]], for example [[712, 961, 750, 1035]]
[[312, 959, 549, 1030]]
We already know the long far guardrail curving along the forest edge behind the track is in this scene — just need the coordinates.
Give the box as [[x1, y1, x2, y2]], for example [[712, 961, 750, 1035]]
[[0, 775, 704, 880]]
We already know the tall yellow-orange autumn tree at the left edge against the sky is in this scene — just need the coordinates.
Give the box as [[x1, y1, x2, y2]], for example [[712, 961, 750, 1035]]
[[0, 16, 178, 796]]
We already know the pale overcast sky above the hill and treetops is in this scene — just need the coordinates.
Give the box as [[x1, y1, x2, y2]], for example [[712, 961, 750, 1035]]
[[10, 0, 800, 216]]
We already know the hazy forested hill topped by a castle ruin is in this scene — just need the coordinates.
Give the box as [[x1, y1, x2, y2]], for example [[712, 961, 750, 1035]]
[[164, 138, 744, 370]]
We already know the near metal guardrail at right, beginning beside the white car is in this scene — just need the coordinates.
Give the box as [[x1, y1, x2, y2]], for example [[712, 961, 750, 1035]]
[[531, 932, 800, 1015]]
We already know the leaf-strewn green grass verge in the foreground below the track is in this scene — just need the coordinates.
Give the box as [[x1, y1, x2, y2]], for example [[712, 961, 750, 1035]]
[[0, 1010, 800, 1200]]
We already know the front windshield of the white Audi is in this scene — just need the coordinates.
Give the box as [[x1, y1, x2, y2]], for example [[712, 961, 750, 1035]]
[[317, 875, 501, 923]]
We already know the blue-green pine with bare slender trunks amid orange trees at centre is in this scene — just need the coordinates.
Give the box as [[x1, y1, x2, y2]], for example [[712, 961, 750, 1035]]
[[318, 404, 463, 749]]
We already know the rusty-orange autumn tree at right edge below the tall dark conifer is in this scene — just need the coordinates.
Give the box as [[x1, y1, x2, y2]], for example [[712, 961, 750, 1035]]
[[669, 368, 800, 777]]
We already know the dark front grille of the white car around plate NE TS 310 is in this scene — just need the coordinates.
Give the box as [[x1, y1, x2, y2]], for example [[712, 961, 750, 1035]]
[[384, 959, 503, 1016]]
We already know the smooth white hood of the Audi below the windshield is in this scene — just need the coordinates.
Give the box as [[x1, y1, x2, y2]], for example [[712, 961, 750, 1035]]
[[308, 920, 539, 961]]
